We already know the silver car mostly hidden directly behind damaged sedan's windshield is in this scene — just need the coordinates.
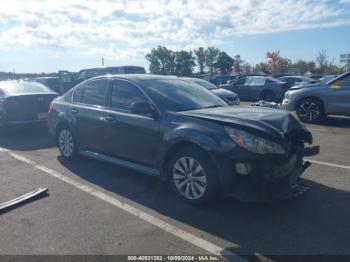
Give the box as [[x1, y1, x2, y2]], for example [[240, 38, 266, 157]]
[[181, 77, 240, 105]]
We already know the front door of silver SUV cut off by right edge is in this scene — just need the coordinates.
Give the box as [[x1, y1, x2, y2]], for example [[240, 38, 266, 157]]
[[326, 74, 350, 115]]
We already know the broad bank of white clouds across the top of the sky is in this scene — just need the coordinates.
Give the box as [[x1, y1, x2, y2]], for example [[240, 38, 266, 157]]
[[0, 0, 350, 59]]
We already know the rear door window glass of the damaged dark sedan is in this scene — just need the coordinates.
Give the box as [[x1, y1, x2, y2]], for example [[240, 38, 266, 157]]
[[82, 79, 108, 106]]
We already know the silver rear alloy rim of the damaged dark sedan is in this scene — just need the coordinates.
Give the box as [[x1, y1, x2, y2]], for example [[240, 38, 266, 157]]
[[57, 126, 78, 160]]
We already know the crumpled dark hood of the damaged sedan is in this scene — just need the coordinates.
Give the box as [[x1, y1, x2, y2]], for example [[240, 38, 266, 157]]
[[181, 106, 312, 143]]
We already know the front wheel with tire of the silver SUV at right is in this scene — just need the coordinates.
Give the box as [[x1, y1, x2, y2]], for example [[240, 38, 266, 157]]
[[296, 98, 325, 123]]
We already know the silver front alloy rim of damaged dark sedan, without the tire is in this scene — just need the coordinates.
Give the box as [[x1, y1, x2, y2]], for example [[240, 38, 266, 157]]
[[173, 156, 207, 199]]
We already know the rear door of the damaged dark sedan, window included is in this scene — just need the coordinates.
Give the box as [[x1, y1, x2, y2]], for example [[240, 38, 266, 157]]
[[70, 79, 109, 152]]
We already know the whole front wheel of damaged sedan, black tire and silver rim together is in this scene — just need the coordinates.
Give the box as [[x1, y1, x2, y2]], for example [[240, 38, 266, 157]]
[[168, 147, 219, 205]]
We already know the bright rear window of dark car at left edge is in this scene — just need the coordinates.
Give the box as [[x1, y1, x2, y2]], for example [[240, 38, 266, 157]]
[[0, 81, 54, 95]]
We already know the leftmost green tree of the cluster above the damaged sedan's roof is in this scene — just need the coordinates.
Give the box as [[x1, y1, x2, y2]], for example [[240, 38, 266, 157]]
[[146, 46, 175, 75]]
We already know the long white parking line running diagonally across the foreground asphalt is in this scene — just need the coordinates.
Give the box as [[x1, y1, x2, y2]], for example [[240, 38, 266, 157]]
[[0, 147, 247, 261]]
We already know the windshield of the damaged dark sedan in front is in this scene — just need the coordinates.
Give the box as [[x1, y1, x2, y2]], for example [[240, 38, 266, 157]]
[[142, 79, 227, 111]]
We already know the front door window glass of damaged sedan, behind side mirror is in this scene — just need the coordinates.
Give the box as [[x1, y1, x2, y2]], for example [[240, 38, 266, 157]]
[[111, 81, 147, 110]]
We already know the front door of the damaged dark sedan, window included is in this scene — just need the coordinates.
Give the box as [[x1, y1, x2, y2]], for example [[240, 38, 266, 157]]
[[104, 80, 160, 166]]
